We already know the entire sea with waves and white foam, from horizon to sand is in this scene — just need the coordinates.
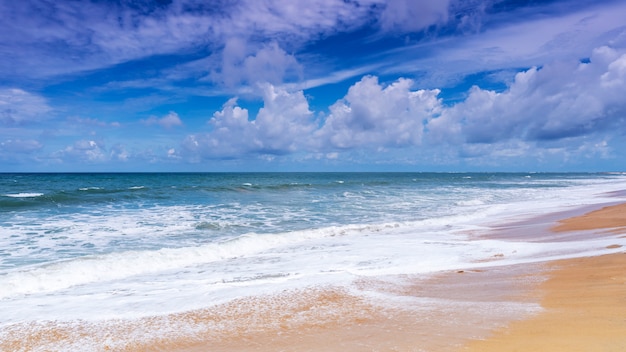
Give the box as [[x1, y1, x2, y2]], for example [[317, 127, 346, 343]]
[[0, 173, 626, 348]]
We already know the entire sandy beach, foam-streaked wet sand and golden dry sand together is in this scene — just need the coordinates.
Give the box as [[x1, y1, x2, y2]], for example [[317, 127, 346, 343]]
[[0, 204, 626, 351]]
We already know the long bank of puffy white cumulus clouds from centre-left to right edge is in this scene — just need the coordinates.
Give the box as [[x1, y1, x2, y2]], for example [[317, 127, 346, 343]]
[[178, 38, 626, 165]]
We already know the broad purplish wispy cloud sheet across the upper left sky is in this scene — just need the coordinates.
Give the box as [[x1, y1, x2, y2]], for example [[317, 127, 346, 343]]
[[0, 0, 381, 77]]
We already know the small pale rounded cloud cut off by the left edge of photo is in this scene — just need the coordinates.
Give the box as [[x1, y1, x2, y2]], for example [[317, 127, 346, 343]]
[[0, 88, 52, 126]]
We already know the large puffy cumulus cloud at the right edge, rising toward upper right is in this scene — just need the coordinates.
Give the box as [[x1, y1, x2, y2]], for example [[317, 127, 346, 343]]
[[429, 46, 626, 148]]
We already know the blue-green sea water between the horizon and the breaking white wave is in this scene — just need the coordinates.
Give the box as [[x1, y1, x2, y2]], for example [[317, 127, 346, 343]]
[[0, 173, 613, 268]]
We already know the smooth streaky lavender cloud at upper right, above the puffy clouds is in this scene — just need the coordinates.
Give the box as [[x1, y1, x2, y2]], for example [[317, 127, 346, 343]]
[[378, 1, 626, 86]]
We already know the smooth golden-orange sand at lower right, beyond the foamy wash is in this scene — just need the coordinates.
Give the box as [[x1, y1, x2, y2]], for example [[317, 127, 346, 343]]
[[462, 204, 626, 352]]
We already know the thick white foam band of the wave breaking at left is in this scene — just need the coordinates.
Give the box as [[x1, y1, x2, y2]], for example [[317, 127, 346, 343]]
[[0, 221, 414, 299]]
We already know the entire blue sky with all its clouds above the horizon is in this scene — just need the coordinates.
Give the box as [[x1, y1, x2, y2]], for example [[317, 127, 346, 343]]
[[0, 0, 626, 172]]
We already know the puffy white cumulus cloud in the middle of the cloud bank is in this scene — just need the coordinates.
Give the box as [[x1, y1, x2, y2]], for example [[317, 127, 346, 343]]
[[316, 76, 442, 149]]
